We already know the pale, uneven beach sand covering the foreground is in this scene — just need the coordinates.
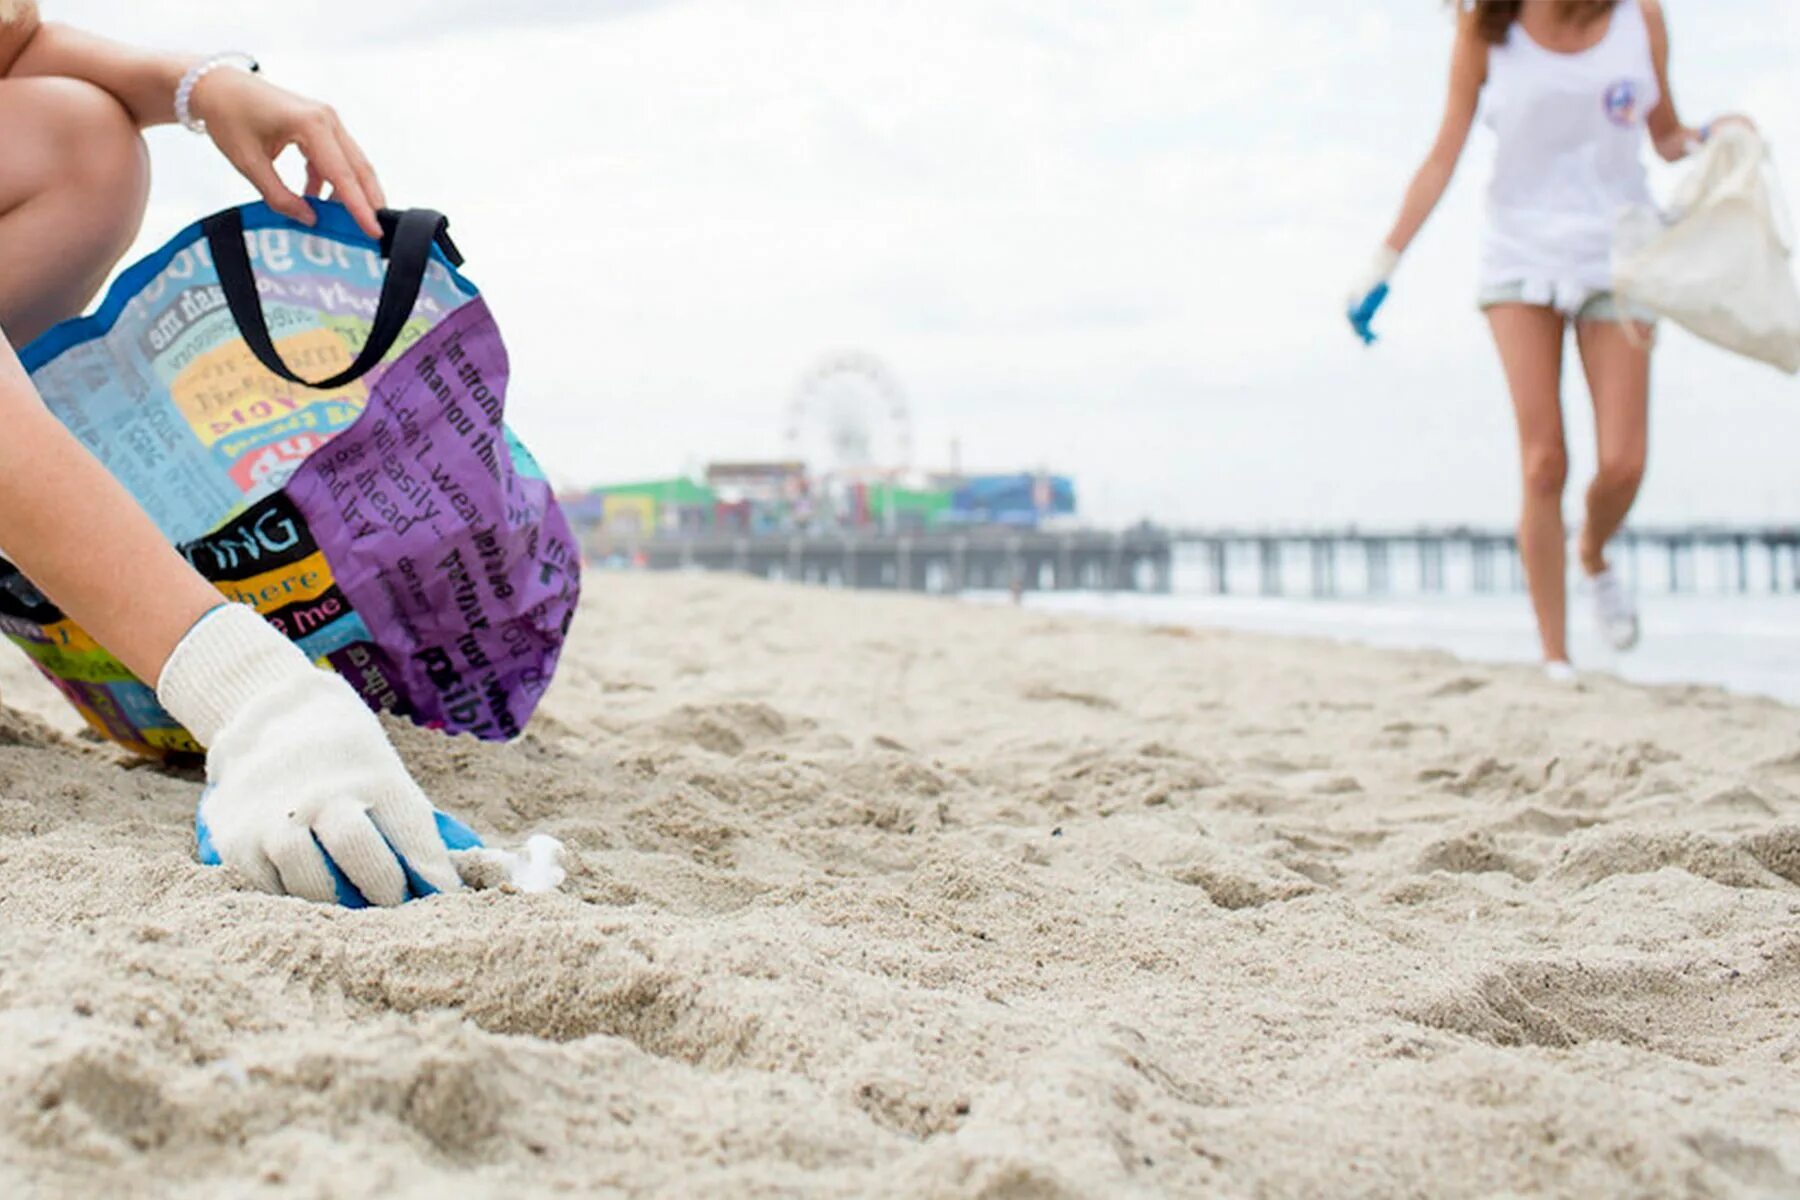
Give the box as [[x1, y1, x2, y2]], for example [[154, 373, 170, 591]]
[[0, 574, 1800, 1198]]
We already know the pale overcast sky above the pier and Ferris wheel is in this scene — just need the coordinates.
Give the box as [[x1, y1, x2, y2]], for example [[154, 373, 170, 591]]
[[43, 0, 1800, 524]]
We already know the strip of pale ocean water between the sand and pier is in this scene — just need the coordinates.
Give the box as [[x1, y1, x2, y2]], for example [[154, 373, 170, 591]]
[[970, 590, 1800, 703]]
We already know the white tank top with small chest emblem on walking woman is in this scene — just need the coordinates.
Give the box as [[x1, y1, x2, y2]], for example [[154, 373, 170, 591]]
[[1481, 0, 1661, 311]]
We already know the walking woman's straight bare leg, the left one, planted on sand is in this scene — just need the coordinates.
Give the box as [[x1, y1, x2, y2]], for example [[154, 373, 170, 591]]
[[1487, 304, 1570, 662]]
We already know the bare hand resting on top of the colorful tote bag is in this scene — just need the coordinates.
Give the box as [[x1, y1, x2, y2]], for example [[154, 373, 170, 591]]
[[191, 68, 387, 239]]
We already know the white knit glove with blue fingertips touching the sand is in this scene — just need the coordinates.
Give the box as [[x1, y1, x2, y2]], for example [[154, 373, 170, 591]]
[[157, 604, 461, 905]]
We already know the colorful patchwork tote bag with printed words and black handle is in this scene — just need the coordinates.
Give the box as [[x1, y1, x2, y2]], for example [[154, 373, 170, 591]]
[[0, 200, 580, 756]]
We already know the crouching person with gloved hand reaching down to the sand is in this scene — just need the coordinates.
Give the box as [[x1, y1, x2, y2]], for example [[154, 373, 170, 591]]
[[0, 0, 459, 905]]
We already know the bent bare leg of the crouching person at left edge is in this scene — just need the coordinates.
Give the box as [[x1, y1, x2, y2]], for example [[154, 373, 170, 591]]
[[0, 79, 149, 345]]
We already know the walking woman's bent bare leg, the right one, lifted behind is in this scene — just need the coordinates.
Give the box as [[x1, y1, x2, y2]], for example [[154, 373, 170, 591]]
[[1575, 320, 1651, 576]]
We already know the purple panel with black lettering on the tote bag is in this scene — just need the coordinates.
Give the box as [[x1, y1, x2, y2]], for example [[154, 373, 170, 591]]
[[286, 299, 580, 739]]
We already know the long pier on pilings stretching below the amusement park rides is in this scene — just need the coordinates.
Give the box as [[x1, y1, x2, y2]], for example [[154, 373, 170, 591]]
[[580, 525, 1800, 597]]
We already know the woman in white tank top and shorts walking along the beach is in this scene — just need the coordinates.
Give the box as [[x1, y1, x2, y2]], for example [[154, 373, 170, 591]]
[[1350, 0, 1742, 680]]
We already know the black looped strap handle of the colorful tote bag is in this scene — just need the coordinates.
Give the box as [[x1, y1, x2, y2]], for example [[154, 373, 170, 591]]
[[200, 209, 463, 390]]
